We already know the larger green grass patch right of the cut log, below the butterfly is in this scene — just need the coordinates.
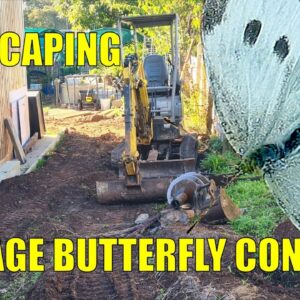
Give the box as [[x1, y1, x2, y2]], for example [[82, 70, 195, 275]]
[[226, 180, 284, 238]]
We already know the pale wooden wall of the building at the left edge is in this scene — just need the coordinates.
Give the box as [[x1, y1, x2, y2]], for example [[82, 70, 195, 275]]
[[0, 0, 27, 163]]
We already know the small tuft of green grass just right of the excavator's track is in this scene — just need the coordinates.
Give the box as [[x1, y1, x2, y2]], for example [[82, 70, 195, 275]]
[[201, 151, 241, 174]]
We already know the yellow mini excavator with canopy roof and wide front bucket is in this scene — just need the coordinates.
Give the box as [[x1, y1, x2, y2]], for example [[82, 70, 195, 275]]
[[97, 14, 197, 204]]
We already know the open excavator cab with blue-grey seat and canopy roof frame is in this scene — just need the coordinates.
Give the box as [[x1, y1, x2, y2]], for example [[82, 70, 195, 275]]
[[118, 14, 182, 141]]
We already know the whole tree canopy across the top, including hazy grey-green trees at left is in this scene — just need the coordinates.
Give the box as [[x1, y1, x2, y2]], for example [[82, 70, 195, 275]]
[[25, 0, 204, 52]]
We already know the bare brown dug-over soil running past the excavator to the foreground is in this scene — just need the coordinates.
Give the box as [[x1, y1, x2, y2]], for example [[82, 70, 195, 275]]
[[0, 110, 300, 299]]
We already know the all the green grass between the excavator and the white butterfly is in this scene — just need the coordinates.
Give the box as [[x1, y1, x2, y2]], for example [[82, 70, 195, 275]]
[[201, 137, 286, 238]]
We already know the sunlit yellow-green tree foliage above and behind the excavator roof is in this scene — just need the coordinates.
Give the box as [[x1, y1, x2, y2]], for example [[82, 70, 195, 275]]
[[52, 0, 204, 54]]
